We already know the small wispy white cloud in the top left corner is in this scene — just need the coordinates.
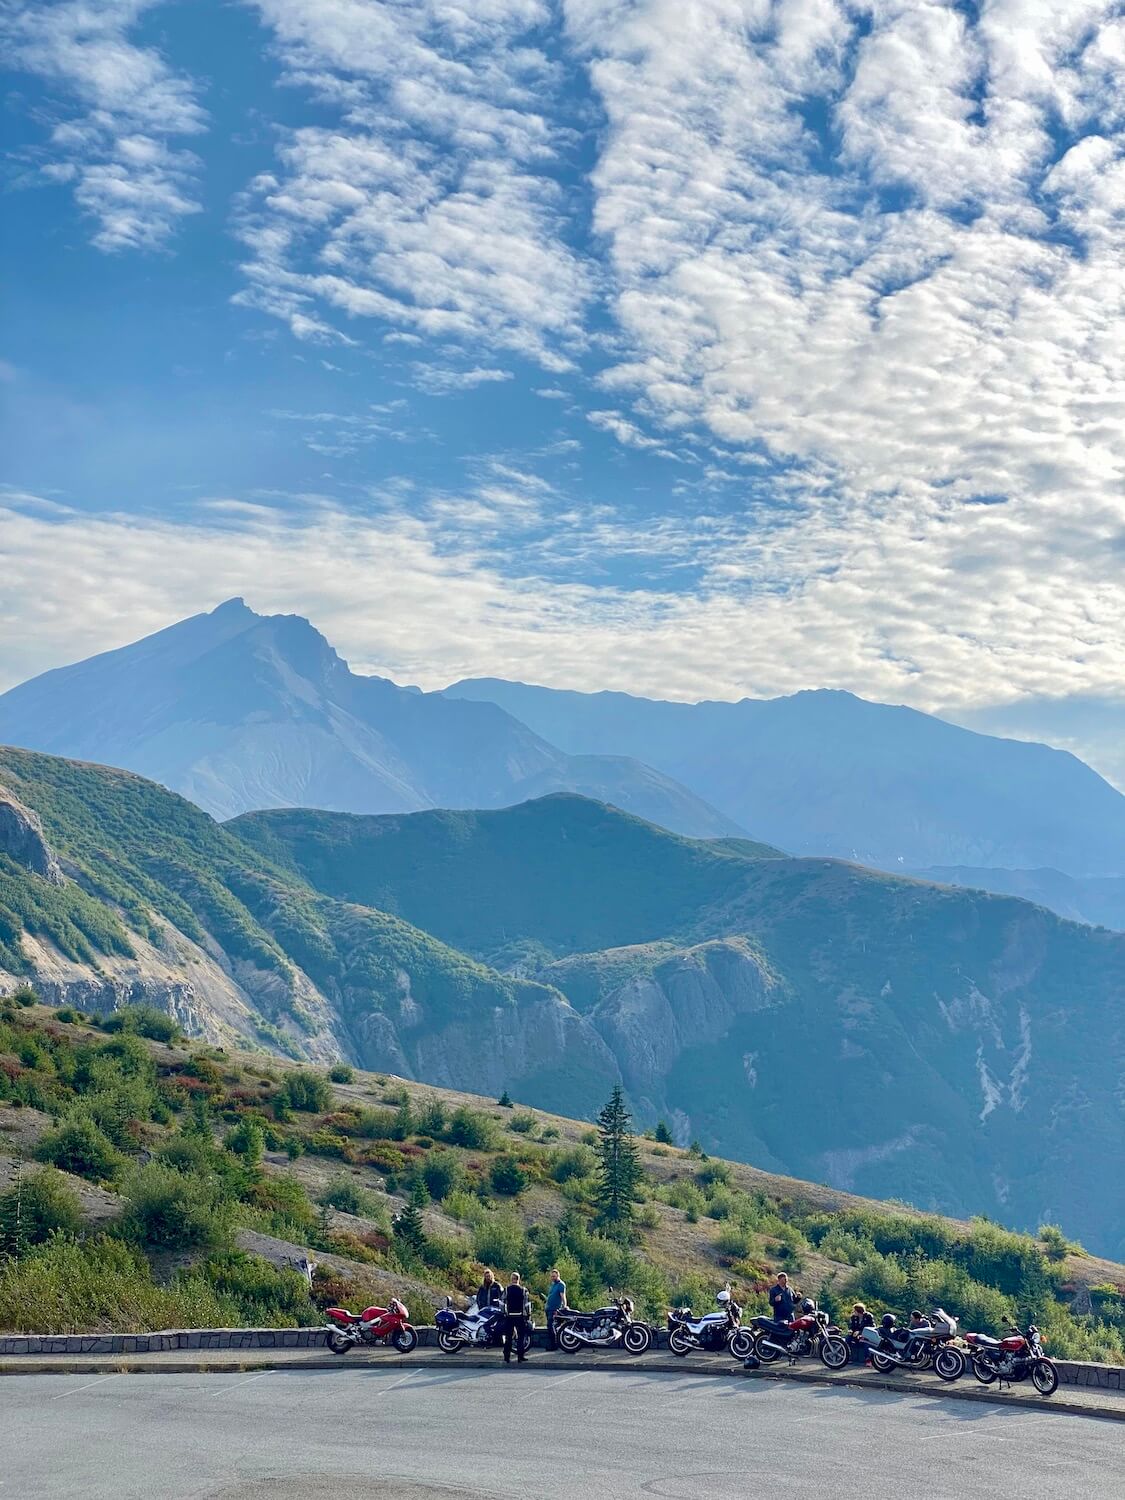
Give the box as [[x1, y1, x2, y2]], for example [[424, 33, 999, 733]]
[[0, 0, 207, 251]]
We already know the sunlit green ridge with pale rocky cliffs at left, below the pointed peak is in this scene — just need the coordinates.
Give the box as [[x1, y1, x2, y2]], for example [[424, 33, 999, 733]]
[[0, 749, 618, 1110]]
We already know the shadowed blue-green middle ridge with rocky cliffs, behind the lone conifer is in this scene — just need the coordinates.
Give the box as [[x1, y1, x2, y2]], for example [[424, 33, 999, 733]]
[[231, 797, 1125, 1251]]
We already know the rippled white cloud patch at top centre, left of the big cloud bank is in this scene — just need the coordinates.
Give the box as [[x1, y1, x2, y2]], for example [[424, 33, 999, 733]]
[[239, 0, 588, 369]]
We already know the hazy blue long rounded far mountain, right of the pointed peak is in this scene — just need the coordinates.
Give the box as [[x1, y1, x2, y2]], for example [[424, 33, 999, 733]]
[[444, 678, 1125, 876]]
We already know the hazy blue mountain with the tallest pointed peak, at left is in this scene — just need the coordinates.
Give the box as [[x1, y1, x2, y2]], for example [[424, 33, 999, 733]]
[[0, 599, 743, 837]]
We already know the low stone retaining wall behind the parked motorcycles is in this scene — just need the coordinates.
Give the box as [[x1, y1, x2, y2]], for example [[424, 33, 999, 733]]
[[0, 1326, 1125, 1392]]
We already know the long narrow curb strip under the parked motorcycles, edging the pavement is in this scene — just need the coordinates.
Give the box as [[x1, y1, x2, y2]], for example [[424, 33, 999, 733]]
[[0, 1350, 1125, 1422]]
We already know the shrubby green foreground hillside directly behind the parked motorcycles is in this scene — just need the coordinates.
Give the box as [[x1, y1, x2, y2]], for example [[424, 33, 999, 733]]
[[0, 995, 1125, 1361]]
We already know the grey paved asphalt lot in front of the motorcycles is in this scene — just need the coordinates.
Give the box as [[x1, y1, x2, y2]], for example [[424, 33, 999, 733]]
[[0, 1365, 1125, 1500]]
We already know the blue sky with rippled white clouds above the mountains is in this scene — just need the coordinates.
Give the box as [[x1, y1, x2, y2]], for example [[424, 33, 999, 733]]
[[0, 0, 1125, 785]]
